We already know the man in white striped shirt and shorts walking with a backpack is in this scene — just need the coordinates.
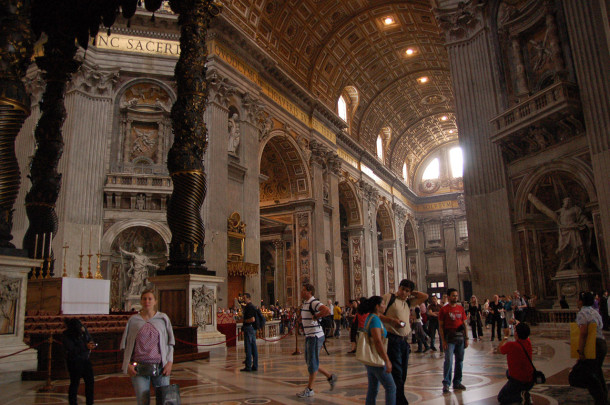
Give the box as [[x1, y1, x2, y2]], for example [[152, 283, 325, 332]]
[[297, 284, 337, 398]]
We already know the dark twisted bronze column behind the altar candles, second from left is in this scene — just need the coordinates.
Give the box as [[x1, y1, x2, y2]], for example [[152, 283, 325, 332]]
[[23, 21, 80, 276]]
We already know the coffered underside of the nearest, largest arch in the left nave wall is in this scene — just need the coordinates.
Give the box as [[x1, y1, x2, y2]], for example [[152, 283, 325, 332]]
[[259, 130, 311, 204]]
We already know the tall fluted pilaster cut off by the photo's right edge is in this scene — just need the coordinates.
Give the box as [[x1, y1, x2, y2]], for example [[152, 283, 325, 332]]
[[563, 0, 610, 280]]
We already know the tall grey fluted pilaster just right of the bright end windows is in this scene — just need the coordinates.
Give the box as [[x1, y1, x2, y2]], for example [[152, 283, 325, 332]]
[[436, 2, 516, 296]]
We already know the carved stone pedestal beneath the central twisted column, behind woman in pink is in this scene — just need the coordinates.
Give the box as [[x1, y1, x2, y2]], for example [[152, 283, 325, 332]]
[[148, 274, 225, 351]]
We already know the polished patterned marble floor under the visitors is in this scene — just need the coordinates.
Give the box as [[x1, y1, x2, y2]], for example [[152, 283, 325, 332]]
[[0, 327, 610, 405]]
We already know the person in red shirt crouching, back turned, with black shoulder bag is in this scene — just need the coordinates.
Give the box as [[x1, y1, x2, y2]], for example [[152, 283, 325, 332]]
[[498, 322, 534, 404]]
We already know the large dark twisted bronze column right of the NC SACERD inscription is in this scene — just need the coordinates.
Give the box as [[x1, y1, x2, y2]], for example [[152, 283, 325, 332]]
[[166, 0, 221, 274]]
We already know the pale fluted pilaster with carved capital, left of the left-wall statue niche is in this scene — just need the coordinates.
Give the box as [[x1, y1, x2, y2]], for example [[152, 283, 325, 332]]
[[54, 63, 119, 277]]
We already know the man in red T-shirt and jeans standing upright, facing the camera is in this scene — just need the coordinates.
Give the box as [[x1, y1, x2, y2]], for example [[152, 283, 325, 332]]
[[438, 288, 468, 394]]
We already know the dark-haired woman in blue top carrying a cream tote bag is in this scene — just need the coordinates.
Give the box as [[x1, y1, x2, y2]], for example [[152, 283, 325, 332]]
[[356, 295, 396, 405]]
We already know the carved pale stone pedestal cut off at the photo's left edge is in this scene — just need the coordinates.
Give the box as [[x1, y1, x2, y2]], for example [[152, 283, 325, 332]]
[[0, 255, 42, 384]]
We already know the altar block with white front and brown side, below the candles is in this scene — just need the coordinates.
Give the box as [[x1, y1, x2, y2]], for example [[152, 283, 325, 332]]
[[26, 277, 110, 315]]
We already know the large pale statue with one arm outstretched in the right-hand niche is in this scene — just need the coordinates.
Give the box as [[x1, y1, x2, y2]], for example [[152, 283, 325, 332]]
[[527, 193, 593, 271]]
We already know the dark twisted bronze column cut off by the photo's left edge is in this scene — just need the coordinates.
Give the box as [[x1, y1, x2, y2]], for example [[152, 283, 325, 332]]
[[0, 0, 34, 248]]
